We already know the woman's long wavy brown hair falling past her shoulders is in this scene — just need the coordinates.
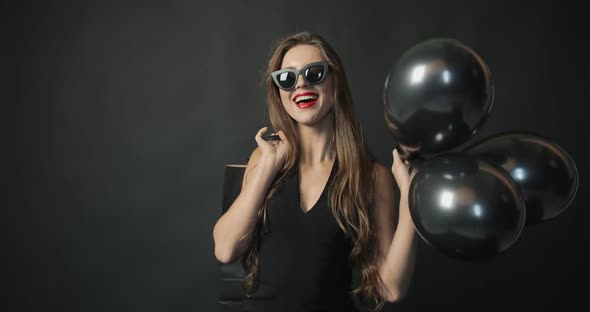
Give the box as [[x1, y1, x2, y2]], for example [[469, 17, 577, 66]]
[[242, 32, 384, 310]]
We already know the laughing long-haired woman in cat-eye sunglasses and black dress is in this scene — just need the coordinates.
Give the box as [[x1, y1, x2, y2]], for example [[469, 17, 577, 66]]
[[213, 32, 416, 311]]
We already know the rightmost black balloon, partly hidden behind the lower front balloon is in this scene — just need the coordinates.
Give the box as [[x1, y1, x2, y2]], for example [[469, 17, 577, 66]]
[[464, 132, 578, 225]]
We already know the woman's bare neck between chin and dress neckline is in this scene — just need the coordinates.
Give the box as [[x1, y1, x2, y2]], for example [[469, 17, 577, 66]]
[[298, 112, 336, 166]]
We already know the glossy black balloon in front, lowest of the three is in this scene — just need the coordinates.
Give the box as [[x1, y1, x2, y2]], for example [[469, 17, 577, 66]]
[[409, 154, 525, 260]]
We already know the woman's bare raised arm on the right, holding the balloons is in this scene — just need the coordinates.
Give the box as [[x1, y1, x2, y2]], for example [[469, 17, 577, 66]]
[[374, 150, 417, 302]]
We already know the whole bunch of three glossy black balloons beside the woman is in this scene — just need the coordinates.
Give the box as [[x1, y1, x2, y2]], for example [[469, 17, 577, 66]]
[[382, 38, 579, 260]]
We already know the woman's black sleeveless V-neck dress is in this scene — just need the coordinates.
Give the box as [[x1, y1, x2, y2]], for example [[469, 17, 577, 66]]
[[244, 161, 358, 312]]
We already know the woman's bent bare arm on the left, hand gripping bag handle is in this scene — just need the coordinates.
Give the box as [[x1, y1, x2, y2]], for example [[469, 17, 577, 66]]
[[213, 128, 288, 263]]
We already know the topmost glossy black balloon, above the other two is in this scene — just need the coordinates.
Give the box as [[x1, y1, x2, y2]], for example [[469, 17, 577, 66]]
[[383, 38, 494, 159]]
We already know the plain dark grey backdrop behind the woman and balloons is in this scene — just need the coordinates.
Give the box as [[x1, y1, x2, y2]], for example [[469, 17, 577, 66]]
[[16, 0, 590, 312]]
